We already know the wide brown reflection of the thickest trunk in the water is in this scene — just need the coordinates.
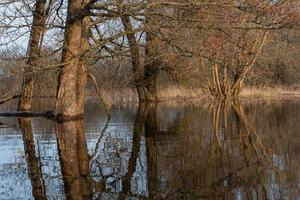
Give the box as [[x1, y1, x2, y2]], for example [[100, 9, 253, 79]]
[[56, 121, 93, 200]]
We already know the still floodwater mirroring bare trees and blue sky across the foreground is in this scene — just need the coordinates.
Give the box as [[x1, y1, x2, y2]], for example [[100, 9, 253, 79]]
[[0, 100, 300, 200]]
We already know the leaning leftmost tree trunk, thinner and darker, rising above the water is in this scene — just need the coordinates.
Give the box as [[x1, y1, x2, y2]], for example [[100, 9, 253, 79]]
[[18, 0, 47, 111]]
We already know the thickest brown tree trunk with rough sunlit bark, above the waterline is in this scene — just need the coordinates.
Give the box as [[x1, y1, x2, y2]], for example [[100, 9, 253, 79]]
[[55, 0, 90, 120]]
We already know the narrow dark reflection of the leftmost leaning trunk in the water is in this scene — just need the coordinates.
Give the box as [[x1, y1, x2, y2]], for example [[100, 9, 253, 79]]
[[19, 119, 47, 200]]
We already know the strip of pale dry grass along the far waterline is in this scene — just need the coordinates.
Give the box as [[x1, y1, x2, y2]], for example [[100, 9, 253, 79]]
[[88, 86, 300, 105]]
